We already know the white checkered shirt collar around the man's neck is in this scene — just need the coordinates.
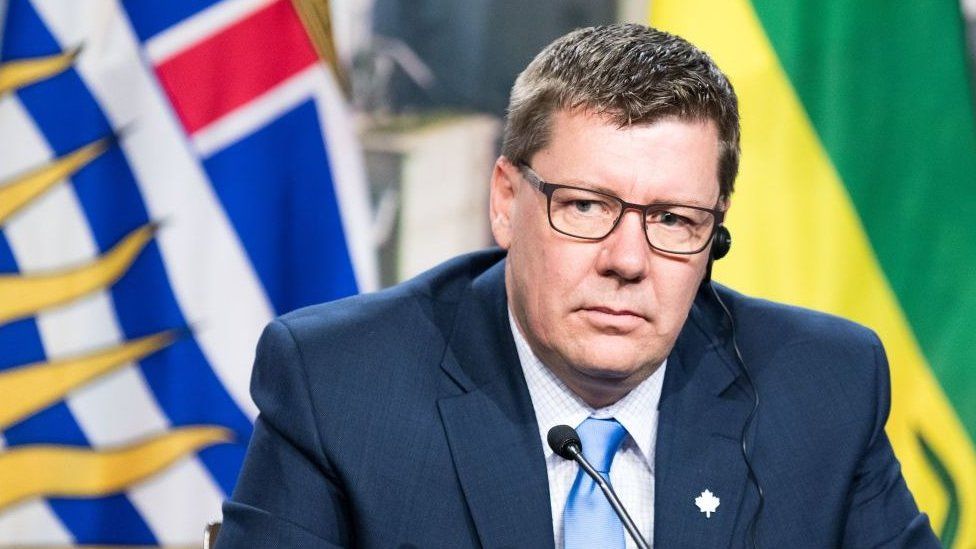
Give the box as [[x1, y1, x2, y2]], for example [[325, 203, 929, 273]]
[[508, 312, 668, 464]]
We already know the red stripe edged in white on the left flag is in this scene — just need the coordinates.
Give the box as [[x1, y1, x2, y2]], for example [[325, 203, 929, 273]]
[[156, 0, 318, 134]]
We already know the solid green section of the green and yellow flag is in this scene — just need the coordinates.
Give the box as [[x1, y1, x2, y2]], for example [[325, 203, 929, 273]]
[[753, 0, 976, 440]]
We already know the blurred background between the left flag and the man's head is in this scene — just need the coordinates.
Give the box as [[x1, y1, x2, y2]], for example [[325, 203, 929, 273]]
[[333, 0, 647, 285]]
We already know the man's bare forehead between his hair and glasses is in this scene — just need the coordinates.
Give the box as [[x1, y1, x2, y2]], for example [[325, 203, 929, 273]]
[[531, 110, 720, 207]]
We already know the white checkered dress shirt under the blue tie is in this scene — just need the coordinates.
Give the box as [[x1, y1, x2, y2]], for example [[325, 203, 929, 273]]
[[508, 313, 667, 549]]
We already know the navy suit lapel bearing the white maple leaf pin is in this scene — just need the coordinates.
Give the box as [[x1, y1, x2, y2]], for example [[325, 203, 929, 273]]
[[654, 288, 753, 547]]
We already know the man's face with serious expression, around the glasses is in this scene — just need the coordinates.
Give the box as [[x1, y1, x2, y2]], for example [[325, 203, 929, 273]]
[[491, 111, 719, 406]]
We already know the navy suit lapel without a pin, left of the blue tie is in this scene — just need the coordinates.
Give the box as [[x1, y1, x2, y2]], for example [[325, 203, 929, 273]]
[[438, 261, 553, 547]]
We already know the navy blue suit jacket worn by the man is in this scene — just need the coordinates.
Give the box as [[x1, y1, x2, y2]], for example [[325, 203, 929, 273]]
[[217, 250, 938, 549]]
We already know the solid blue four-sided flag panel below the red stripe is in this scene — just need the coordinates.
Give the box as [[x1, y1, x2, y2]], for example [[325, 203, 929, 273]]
[[204, 96, 357, 314]]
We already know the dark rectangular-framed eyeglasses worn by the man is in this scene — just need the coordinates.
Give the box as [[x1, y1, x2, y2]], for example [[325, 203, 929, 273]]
[[519, 164, 725, 255]]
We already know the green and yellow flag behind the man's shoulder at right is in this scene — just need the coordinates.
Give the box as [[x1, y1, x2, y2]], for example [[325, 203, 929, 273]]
[[651, 0, 976, 549]]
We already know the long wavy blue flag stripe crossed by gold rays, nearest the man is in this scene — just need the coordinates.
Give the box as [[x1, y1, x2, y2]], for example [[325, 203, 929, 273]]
[[3, 0, 252, 524]]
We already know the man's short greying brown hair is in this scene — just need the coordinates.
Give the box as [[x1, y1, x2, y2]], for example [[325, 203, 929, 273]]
[[502, 23, 739, 198]]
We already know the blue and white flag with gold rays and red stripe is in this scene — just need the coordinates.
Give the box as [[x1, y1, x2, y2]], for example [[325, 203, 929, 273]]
[[0, 0, 376, 545]]
